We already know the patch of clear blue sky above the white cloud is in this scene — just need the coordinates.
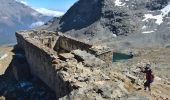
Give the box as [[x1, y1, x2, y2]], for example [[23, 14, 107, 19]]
[[18, 0, 78, 12]]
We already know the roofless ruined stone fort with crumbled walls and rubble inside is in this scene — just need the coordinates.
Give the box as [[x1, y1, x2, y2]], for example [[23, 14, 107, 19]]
[[16, 30, 112, 98]]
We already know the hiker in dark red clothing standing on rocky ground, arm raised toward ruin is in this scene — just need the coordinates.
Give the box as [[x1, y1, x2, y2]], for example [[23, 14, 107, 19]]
[[140, 64, 154, 91]]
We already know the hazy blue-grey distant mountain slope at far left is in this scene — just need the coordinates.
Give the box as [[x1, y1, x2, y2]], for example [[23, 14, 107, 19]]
[[0, 0, 51, 44]]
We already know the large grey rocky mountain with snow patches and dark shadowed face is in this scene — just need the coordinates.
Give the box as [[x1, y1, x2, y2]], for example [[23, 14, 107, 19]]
[[41, 0, 170, 47]]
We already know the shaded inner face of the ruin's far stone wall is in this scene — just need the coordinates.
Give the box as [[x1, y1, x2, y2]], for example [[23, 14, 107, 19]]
[[54, 36, 112, 61]]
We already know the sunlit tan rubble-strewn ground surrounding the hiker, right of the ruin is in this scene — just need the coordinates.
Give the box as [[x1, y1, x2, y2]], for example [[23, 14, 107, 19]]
[[51, 48, 170, 100]]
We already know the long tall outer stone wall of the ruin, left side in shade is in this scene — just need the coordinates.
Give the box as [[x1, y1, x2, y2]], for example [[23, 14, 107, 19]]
[[16, 32, 70, 98]]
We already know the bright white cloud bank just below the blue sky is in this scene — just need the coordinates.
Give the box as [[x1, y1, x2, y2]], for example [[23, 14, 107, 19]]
[[34, 8, 64, 17]]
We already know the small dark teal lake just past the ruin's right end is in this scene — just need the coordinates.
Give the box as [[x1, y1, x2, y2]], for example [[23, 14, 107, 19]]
[[112, 52, 133, 62]]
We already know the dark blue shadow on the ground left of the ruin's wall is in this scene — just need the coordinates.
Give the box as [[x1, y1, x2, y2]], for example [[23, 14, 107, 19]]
[[0, 46, 56, 100]]
